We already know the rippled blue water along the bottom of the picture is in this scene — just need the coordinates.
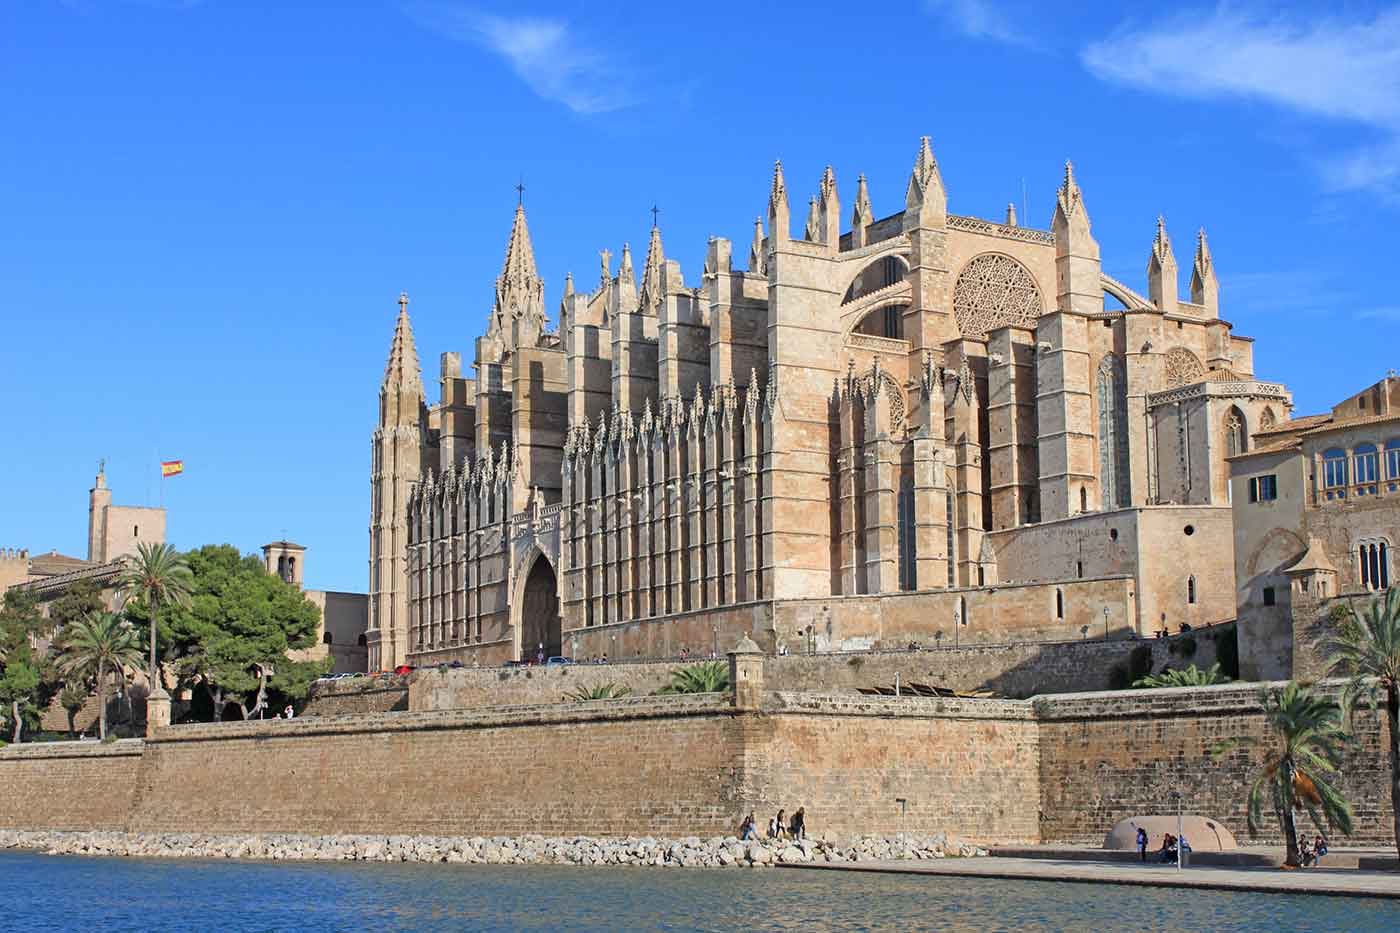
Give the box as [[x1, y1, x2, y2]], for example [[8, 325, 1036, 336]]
[[0, 852, 1400, 933]]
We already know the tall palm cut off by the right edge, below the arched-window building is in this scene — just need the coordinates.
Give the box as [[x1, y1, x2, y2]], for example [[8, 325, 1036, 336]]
[[1323, 587, 1400, 853]]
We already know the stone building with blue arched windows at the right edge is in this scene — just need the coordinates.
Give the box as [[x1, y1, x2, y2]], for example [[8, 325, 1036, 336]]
[[1229, 375, 1400, 679]]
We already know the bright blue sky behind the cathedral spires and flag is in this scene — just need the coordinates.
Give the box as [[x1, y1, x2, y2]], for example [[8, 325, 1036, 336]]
[[0, 0, 1400, 590]]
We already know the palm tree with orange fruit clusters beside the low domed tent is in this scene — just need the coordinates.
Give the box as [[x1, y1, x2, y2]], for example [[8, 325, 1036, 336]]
[[1215, 681, 1351, 869]]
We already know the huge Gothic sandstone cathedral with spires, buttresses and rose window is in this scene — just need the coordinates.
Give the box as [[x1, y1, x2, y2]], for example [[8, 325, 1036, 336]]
[[368, 137, 1292, 670]]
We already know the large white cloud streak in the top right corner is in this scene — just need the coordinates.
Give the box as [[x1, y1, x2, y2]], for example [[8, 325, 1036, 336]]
[[1081, 4, 1400, 199]]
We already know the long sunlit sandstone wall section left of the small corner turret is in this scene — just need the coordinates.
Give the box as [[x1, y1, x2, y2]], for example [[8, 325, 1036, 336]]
[[132, 696, 738, 835]]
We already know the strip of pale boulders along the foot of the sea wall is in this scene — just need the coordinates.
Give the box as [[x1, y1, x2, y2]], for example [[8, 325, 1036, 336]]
[[0, 831, 987, 869]]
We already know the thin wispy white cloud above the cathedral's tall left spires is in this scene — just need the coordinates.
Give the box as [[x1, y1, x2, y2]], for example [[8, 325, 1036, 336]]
[[409, 3, 637, 113]]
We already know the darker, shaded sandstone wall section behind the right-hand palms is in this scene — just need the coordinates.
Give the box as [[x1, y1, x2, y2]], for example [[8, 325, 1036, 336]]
[[1035, 685, 1393, 845]]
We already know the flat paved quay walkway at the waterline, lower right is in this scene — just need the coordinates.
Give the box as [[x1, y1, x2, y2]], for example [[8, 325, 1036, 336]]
[[780, 856, 1400, 899]]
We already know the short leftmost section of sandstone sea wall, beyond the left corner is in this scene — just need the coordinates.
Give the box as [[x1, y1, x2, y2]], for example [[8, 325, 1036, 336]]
[[0, 738, 143, 829]]
